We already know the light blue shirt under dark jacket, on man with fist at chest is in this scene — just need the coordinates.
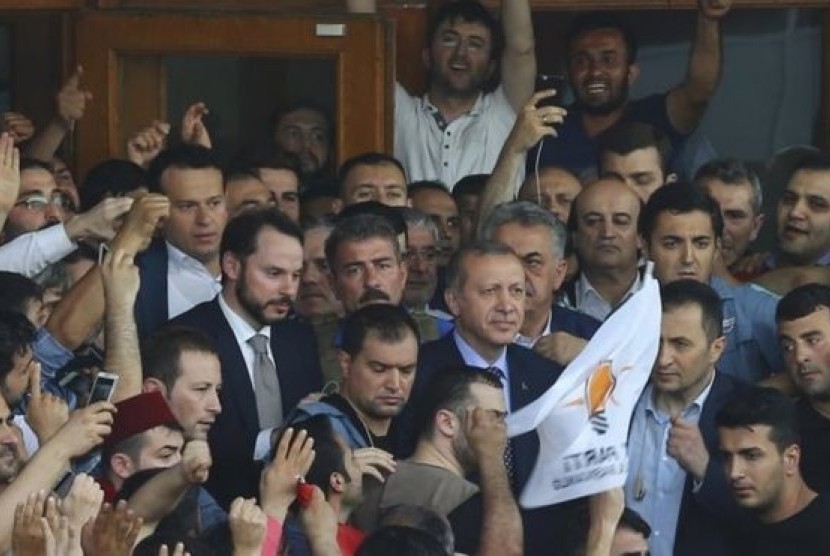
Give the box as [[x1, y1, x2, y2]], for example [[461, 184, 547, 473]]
[[625, 382, 712, 556]]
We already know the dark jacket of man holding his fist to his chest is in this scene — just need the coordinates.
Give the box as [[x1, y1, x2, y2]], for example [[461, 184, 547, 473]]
[[674, 372, 747, 556]]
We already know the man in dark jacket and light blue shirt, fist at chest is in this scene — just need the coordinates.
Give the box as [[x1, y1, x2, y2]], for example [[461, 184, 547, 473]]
[[625, 280, 742, 556]]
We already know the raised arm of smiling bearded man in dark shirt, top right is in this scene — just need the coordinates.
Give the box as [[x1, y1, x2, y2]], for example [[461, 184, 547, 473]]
[[666, 0, 732, 133]]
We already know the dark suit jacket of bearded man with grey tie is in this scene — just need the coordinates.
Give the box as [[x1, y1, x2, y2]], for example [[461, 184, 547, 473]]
[[172, 299, 322, 508]]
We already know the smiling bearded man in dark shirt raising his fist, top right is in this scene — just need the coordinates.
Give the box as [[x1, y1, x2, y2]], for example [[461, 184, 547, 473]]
[[527, 0, 732, 181]]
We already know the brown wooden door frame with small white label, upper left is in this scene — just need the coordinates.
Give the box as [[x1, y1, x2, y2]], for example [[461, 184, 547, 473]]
[[76, 13, 392, 176]]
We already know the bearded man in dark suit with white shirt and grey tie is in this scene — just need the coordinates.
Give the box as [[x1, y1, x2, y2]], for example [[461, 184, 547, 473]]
[[174, 208, 322, 507]]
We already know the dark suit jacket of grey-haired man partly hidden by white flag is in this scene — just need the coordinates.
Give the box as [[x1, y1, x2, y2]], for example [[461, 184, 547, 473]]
[[410, 334, 571, 556]]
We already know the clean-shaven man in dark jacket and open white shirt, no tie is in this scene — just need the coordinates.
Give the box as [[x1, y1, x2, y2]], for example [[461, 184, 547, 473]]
[[135, 145, 228, 338]]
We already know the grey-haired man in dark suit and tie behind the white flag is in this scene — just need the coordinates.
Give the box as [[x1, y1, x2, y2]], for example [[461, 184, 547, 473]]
[[411, 241, 562, 554]]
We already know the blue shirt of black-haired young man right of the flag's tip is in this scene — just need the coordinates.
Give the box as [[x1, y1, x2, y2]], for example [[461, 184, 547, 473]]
[[709, 276, 784, 383]]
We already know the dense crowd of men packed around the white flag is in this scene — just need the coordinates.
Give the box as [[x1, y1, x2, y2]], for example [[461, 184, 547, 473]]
[[0, 0, 830, 556]]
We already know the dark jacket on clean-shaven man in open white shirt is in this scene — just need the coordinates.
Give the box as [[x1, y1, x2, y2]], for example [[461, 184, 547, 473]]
[[135, 239, 168, 339]]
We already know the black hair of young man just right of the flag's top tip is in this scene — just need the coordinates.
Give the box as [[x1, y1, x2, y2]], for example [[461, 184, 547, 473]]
[[637, 182, 723, 243]]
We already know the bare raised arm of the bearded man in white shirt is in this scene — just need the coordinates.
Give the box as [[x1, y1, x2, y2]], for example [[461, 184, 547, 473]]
[[501, 0, 536, 112]]
